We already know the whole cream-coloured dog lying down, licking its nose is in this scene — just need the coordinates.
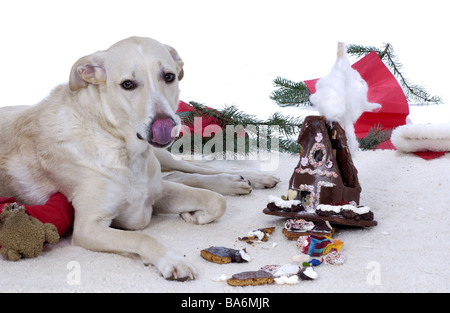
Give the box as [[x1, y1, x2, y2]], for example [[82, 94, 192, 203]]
[[0, 37, 278, 280]]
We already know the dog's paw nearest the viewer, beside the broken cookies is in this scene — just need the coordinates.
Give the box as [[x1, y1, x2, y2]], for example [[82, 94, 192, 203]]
[[157, 251, 197, 282]]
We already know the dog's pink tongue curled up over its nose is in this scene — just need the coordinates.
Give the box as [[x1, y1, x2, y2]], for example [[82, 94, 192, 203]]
[[136, 116, 179, 148]]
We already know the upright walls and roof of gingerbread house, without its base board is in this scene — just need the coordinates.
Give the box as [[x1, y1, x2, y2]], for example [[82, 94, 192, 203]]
[[288, 116, 361, 207]]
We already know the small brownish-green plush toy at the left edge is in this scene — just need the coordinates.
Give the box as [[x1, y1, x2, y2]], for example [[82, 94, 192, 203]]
[[0, 203, 59, 261]]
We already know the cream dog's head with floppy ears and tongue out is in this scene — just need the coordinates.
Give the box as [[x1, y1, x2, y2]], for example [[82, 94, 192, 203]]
[[69, 37, 184, 148]]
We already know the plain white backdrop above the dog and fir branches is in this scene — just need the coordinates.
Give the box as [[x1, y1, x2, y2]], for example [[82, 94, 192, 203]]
[[0, 0, 450, 122]]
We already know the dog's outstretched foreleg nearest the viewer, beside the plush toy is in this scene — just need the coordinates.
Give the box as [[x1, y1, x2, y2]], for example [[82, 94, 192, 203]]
[[72, 193, 196, 281]]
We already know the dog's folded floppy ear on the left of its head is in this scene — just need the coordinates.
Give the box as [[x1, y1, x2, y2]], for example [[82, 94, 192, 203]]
[[69, 51, 106, 91]]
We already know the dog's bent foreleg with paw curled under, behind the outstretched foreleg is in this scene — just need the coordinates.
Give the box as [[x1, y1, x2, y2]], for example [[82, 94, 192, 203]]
[[154, 181, 226, 224]]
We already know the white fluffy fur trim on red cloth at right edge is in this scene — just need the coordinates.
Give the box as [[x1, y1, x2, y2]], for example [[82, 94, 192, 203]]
[[391, 123, 450, 152]]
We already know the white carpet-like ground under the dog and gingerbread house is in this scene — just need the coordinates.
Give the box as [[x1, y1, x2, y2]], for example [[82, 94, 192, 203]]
[[0, 151, 450, 293]]
